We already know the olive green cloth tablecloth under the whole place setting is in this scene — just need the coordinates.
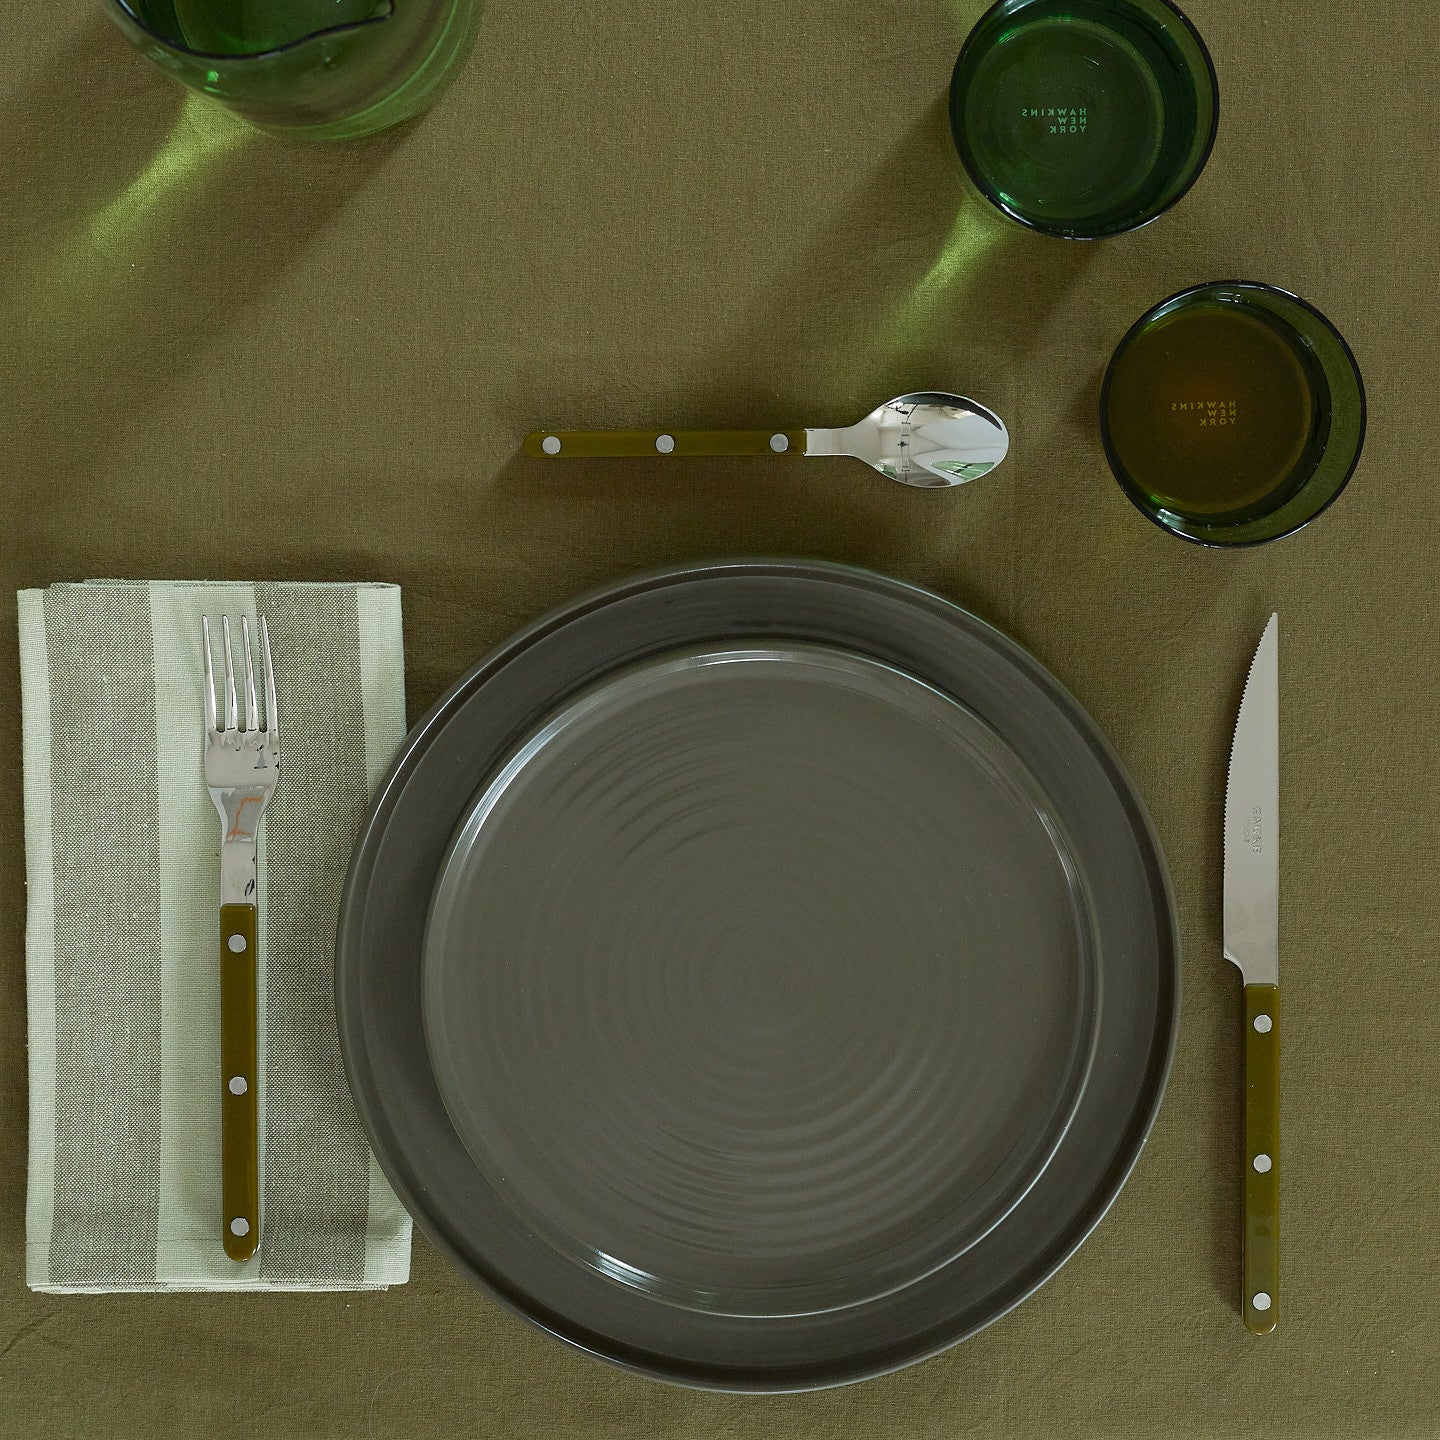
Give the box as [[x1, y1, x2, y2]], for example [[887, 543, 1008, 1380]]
[[0, 0, 1440, 1440]]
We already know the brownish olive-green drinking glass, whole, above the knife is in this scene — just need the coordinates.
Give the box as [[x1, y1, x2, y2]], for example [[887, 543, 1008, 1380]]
[[1100, 281, 1365, 546]]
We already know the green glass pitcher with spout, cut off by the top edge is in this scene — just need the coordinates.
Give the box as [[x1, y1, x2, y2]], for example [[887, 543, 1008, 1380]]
[[105, 0, 480, 140]]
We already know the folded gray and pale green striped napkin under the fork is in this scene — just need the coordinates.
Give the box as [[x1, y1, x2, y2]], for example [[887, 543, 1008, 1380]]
[[19, 580, 410, 1292]]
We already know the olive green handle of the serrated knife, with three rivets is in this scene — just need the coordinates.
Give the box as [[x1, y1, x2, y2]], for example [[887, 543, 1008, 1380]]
[[1240, 985, 1280, 1335]]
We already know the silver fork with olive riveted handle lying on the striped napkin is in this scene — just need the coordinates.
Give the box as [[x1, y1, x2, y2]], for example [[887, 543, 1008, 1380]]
[[200, 615, 279, 1260]]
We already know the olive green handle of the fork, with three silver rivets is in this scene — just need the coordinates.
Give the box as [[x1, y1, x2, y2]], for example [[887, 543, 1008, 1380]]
[[220, 904, 261, 1260]]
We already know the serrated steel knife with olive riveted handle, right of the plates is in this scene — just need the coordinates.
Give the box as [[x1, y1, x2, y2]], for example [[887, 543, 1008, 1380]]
[[1225, 615, 1280, 1335]]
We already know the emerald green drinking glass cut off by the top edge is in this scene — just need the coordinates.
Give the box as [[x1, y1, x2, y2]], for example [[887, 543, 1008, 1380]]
[[950, 0, 1220, 240]]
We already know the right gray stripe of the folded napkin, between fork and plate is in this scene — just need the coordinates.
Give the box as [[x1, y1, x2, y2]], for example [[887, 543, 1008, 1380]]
[[255, 585, 370, 1284]]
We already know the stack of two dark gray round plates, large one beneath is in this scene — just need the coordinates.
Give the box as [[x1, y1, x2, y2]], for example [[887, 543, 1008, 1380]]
[[337, 562, 1178, 1390]]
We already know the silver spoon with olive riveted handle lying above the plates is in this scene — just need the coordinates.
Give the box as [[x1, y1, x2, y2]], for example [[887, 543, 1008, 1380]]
[[526, 390, 1009, 490]]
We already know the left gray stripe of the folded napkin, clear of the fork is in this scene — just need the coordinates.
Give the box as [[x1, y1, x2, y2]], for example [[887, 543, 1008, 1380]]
[[45, 589, 161, 1284]]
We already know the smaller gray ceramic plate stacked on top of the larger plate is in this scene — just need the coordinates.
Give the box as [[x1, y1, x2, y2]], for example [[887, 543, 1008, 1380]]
[[422, 642, 1094, 1316]]
